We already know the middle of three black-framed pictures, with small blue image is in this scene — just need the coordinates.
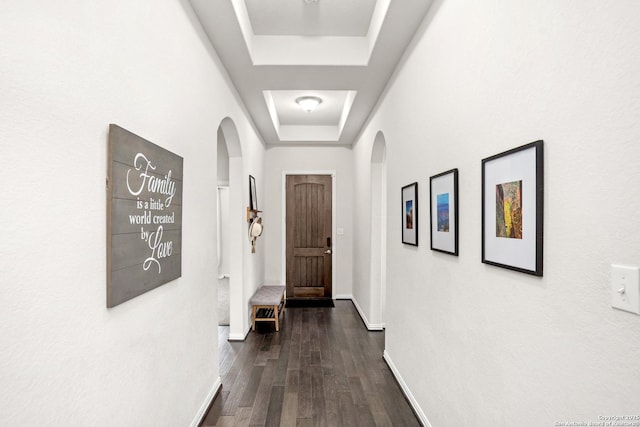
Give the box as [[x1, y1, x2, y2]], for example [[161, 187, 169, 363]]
[[429, 169, 458, 256]]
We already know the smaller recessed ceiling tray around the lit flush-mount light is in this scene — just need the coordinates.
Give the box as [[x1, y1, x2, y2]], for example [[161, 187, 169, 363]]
[[263, 90, 357, 142]]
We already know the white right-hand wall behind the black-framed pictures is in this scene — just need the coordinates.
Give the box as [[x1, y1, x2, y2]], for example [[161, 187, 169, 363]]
[[354, 0, 640, 426]]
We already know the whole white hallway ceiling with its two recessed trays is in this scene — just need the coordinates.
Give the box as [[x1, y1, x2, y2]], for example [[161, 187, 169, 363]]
[[191, 0, 431, 145]]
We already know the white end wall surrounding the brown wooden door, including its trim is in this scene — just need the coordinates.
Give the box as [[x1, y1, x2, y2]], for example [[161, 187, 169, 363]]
[[258, 147, 354, 298]]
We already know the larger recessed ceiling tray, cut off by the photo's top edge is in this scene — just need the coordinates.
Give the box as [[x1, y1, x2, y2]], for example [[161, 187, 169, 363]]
[[231, 0, 391, 65]]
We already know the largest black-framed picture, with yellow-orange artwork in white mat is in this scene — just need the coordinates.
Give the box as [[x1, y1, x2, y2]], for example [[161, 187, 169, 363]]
[[482, 141, 544, 276]]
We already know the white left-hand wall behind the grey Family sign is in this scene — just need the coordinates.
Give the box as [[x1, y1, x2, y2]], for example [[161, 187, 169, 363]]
[[0, 0, 264, 426]]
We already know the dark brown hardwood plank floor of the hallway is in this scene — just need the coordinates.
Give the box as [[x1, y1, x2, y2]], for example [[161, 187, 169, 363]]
[[202, 300, 420, 426]]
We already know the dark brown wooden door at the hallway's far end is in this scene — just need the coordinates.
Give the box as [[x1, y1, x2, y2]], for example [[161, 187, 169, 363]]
[[287, 175, 332, 299]]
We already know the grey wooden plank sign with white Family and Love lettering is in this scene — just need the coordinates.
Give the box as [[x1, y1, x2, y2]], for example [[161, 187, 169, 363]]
[[107, 124, 182, 307]]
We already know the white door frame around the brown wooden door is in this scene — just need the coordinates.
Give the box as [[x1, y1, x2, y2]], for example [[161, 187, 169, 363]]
[[281, 169, 339, 299]]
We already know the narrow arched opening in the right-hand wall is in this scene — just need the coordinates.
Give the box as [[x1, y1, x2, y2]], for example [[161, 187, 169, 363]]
[[369, 132, 387, 329]]
